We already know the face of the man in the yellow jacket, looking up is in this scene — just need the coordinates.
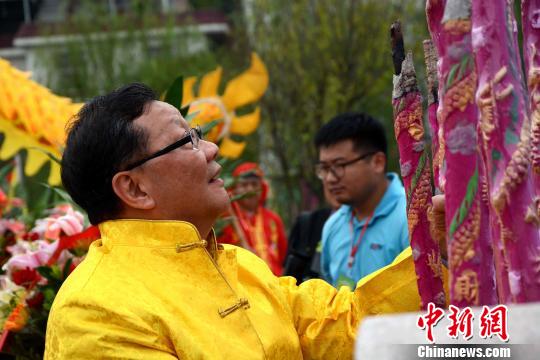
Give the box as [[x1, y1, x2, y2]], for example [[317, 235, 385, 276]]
[[134, 101, 229, 224]]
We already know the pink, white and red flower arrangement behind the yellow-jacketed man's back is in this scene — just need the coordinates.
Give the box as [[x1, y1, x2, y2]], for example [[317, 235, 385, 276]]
[[0, 198, 99, 359]]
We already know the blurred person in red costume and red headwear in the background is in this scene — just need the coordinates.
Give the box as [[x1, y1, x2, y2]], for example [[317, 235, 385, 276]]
[[218, 162, 287, 275]]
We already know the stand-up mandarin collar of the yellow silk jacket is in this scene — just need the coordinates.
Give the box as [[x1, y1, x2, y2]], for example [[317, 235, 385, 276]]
[[99, 219, 217, 259]]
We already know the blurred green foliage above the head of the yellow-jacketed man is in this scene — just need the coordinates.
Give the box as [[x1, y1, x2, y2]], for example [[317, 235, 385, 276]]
[[37, 0, 216, 101]]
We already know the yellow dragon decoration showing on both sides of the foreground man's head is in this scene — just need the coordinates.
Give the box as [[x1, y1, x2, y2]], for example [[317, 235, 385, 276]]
[[0, 53, 268, 185]]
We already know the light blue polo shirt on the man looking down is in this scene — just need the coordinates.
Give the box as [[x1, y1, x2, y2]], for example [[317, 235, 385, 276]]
[[321, 173, 409, 286]]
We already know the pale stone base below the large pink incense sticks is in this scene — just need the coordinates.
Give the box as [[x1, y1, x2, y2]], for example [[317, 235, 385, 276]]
[[356, 303, 540, 360]]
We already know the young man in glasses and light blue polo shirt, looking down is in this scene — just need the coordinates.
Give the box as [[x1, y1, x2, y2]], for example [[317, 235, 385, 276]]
[[315, 113, 409, 289]]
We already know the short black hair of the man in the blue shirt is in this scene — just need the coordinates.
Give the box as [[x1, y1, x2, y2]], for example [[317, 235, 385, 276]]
[[315, 113, 388, 155]]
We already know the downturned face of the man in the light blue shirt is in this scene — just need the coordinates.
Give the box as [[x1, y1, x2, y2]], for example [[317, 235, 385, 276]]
[[319, 140, 384, 206]]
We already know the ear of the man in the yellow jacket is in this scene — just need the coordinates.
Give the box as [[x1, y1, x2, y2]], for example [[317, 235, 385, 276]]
[[112, 171, 156, 210]]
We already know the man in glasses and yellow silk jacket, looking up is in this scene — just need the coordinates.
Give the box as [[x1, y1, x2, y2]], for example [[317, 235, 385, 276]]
[[45, 84, 442, 359]]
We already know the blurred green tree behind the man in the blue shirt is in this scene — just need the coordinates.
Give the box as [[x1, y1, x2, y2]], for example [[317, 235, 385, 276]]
[[247, 0, 428, 223]]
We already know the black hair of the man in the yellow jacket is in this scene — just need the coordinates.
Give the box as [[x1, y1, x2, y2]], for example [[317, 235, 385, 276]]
[[62, 83, 157, 224]]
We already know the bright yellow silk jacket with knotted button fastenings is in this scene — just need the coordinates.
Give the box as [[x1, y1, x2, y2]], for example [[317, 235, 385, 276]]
[[45, 220, 420, 360]]
